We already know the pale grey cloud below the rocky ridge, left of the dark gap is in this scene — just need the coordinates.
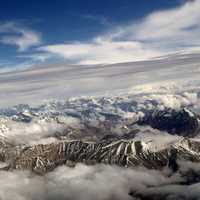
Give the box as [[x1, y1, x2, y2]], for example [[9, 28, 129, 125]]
[[0, 164, 179, 200]]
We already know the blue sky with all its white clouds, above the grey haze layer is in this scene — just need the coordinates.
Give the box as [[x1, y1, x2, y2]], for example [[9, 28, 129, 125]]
[[0, 0, 200, 71]]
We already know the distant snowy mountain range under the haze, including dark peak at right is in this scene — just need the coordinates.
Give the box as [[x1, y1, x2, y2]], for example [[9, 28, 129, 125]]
[[0, 96, 200, 139]]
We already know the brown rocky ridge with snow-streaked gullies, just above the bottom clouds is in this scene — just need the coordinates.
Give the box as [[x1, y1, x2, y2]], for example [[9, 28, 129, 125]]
[[0, 139, 200, 174]]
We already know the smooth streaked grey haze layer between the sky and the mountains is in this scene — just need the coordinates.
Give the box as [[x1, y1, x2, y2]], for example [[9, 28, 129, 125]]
[[0, 52, 200, 107]]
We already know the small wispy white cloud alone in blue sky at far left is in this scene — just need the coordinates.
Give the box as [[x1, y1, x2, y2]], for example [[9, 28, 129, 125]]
[[0, 22, 41, 52]]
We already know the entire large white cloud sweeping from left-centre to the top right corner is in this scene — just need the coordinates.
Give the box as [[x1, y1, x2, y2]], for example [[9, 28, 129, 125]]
[[38, 0, 200, 64]]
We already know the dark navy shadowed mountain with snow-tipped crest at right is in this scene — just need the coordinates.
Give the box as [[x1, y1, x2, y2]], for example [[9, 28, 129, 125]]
[[137, 109, 199, 137]]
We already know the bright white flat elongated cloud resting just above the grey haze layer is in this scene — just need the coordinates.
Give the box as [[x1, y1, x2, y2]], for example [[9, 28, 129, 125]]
[[39, 38, 159, 64]]
